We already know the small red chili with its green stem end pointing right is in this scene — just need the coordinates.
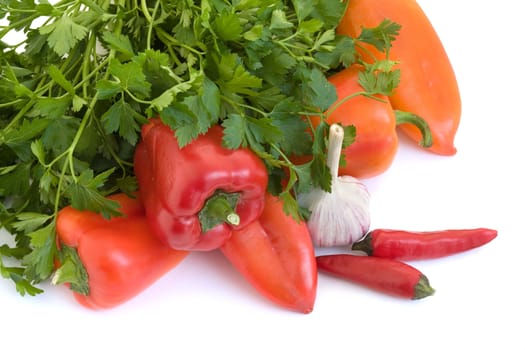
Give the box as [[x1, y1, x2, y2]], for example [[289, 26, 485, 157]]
[[316, 254, 434, 299]]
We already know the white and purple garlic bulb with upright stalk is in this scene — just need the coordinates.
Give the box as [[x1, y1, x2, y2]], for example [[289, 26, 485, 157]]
[[298, 124, 370, 247]]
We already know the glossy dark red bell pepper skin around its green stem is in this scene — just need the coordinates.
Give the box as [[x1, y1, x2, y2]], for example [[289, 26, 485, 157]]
[[134, 119, 268, 251]]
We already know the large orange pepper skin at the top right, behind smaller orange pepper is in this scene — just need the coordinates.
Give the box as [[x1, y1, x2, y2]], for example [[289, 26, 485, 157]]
[[337, 0, 461, 155]]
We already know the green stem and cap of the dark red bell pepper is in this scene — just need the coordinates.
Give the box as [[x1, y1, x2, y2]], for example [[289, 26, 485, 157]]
[[199, 191, 240, 233]]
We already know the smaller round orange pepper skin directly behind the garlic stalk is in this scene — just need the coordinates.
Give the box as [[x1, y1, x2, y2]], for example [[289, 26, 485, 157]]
[[320, 65, 398, 178]]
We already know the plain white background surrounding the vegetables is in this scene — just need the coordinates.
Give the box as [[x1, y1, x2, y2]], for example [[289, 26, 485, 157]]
[[0, 0, 525, 350]]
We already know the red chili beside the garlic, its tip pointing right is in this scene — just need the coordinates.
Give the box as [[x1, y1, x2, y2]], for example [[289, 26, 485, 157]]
[[352, 228, 498, 260]]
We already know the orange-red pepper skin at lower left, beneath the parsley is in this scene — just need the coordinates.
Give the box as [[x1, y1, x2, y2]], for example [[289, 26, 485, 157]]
[[56, 194, 188, 309]]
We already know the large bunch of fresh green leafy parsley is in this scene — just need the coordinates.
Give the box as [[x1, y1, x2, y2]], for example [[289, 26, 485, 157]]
[[0, 0, 399, 295]]
